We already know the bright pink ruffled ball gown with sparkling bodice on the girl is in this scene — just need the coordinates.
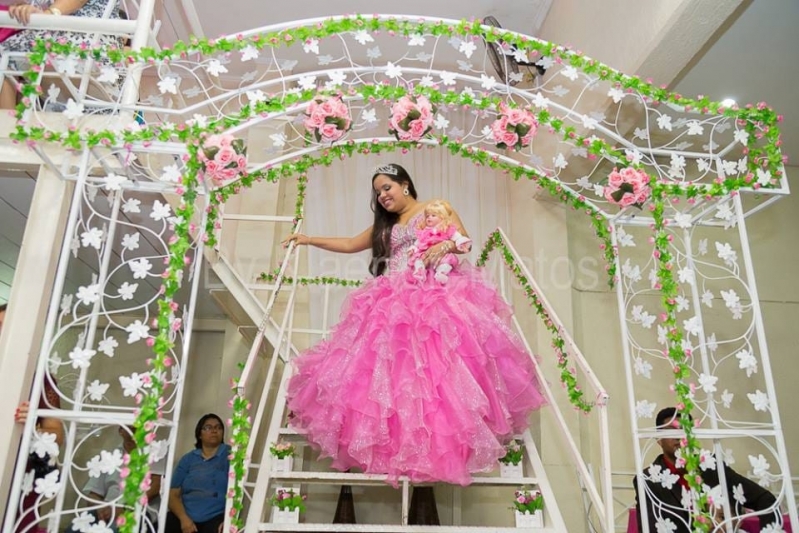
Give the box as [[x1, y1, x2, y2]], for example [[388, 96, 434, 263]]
[[288, 210, 545, 486]]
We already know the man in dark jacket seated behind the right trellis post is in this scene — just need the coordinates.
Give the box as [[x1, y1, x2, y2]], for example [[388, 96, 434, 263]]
[[633, 407, 782, 533]]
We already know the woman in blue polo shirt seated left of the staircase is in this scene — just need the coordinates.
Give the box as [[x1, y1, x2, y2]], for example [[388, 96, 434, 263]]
[[164, 413, 230, 533]]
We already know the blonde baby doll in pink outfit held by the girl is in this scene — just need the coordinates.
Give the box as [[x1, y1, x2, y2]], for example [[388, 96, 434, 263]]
[[410, 200, 472, 284]]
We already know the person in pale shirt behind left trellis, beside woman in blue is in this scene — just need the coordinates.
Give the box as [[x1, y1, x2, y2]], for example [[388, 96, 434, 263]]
[[66, 426, 164, 533]]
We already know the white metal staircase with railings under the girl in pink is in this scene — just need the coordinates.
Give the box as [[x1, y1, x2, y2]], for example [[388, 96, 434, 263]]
[[209, 204, 614, 532]]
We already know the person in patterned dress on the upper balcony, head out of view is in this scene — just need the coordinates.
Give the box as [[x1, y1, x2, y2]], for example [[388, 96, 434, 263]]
[[0, 0, 120, 109]]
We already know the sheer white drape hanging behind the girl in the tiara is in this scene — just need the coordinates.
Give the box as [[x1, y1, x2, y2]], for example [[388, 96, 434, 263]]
[[305, 143, 510, 328]]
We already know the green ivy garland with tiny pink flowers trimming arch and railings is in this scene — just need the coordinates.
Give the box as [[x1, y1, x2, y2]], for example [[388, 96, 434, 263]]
[[12, 15, 784, 533]]
